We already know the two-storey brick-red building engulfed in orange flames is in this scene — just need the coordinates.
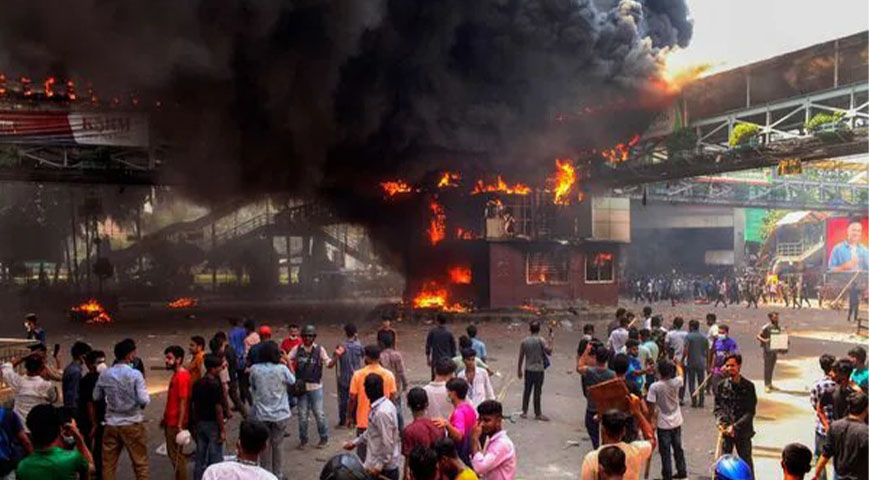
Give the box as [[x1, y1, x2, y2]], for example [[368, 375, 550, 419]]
[[384, 159, 630, 311]]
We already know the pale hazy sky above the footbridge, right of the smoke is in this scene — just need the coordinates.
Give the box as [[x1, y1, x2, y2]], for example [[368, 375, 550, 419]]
[[669, 0, 869, 71]]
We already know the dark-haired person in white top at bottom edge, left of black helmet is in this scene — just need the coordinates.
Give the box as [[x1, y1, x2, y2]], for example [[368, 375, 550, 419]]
[[202, 419, 278, 480]]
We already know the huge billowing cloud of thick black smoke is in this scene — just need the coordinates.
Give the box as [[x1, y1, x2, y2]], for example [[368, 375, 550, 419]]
[[0, 0, 692, 266]]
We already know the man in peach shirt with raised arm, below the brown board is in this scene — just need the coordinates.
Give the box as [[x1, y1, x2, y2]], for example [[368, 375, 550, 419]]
[[580, 397, 655, 480]]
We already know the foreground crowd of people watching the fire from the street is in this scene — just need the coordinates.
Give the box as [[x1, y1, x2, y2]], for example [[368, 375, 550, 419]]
[[0, 307, 869, 480]]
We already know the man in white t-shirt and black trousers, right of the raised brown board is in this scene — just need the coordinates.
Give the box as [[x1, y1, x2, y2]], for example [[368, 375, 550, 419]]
[[646, 358, 688, 480]]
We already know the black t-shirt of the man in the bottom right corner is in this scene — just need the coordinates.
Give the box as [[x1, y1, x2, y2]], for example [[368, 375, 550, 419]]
[[824, 418, 869, 480]]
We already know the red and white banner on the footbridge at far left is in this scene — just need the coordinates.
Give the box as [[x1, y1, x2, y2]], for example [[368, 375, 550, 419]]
[[0, 112, 148, 148]]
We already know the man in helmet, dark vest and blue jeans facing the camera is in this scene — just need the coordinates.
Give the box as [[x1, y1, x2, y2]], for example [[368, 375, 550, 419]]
[[289, 325, 335, 449]]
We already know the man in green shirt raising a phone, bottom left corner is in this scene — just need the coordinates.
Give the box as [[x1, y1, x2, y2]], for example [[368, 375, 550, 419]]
[[15, 405, 95, 480]]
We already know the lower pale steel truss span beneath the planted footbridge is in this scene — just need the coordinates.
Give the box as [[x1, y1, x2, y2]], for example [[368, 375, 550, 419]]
[[614, 177, 869, 213]]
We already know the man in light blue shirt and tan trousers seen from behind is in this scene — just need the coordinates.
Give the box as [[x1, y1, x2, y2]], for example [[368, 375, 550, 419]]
[[94, 338, 150, 480]]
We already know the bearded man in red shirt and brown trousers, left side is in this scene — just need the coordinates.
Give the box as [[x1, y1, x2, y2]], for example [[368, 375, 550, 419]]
[[160, 345, 193, 480]]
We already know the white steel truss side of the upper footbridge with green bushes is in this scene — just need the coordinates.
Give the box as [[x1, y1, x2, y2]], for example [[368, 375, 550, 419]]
[[593, 83, 869, 186]]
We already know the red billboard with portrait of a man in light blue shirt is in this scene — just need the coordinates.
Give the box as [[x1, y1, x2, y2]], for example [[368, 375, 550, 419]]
[[827, 217, 869, 272]]
